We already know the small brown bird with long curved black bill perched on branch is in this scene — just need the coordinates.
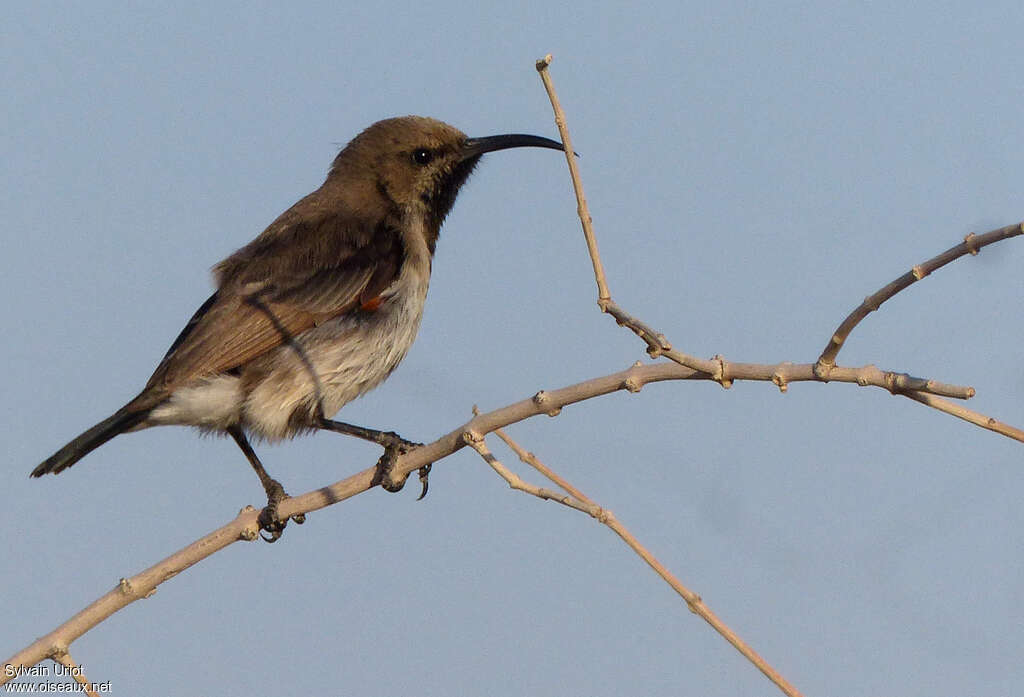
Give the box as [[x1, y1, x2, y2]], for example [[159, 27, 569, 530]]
[[31, 116, 564, 541]]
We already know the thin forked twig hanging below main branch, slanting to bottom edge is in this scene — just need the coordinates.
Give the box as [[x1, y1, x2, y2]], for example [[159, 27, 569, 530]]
[[463, 431, 800, 697]]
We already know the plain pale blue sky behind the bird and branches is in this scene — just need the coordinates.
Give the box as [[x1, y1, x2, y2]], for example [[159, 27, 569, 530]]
[[6, 2, 1024, 697]]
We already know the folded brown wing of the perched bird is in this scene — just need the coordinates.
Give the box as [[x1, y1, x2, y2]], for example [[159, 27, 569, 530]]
[[144, 209, 402, 396]]
